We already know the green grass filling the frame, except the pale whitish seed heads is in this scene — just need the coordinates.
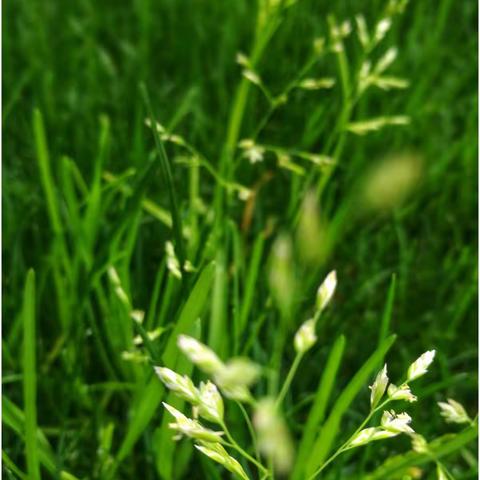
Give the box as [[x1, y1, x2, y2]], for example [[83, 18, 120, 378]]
[[2, 0, 478, 480]]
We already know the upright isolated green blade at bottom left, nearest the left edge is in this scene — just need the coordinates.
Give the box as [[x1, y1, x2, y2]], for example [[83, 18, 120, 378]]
[[22, 270, 40, 480]]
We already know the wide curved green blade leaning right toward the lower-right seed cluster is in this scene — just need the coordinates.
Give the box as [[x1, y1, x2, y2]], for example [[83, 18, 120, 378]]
[[306, 335, 396, 478]]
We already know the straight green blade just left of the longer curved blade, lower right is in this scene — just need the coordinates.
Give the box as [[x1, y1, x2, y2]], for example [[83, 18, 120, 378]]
[[292, 335, 345, 480]]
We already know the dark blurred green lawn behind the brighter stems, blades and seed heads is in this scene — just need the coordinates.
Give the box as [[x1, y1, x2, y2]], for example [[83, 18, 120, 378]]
[[2, 0, 478, 479]]
